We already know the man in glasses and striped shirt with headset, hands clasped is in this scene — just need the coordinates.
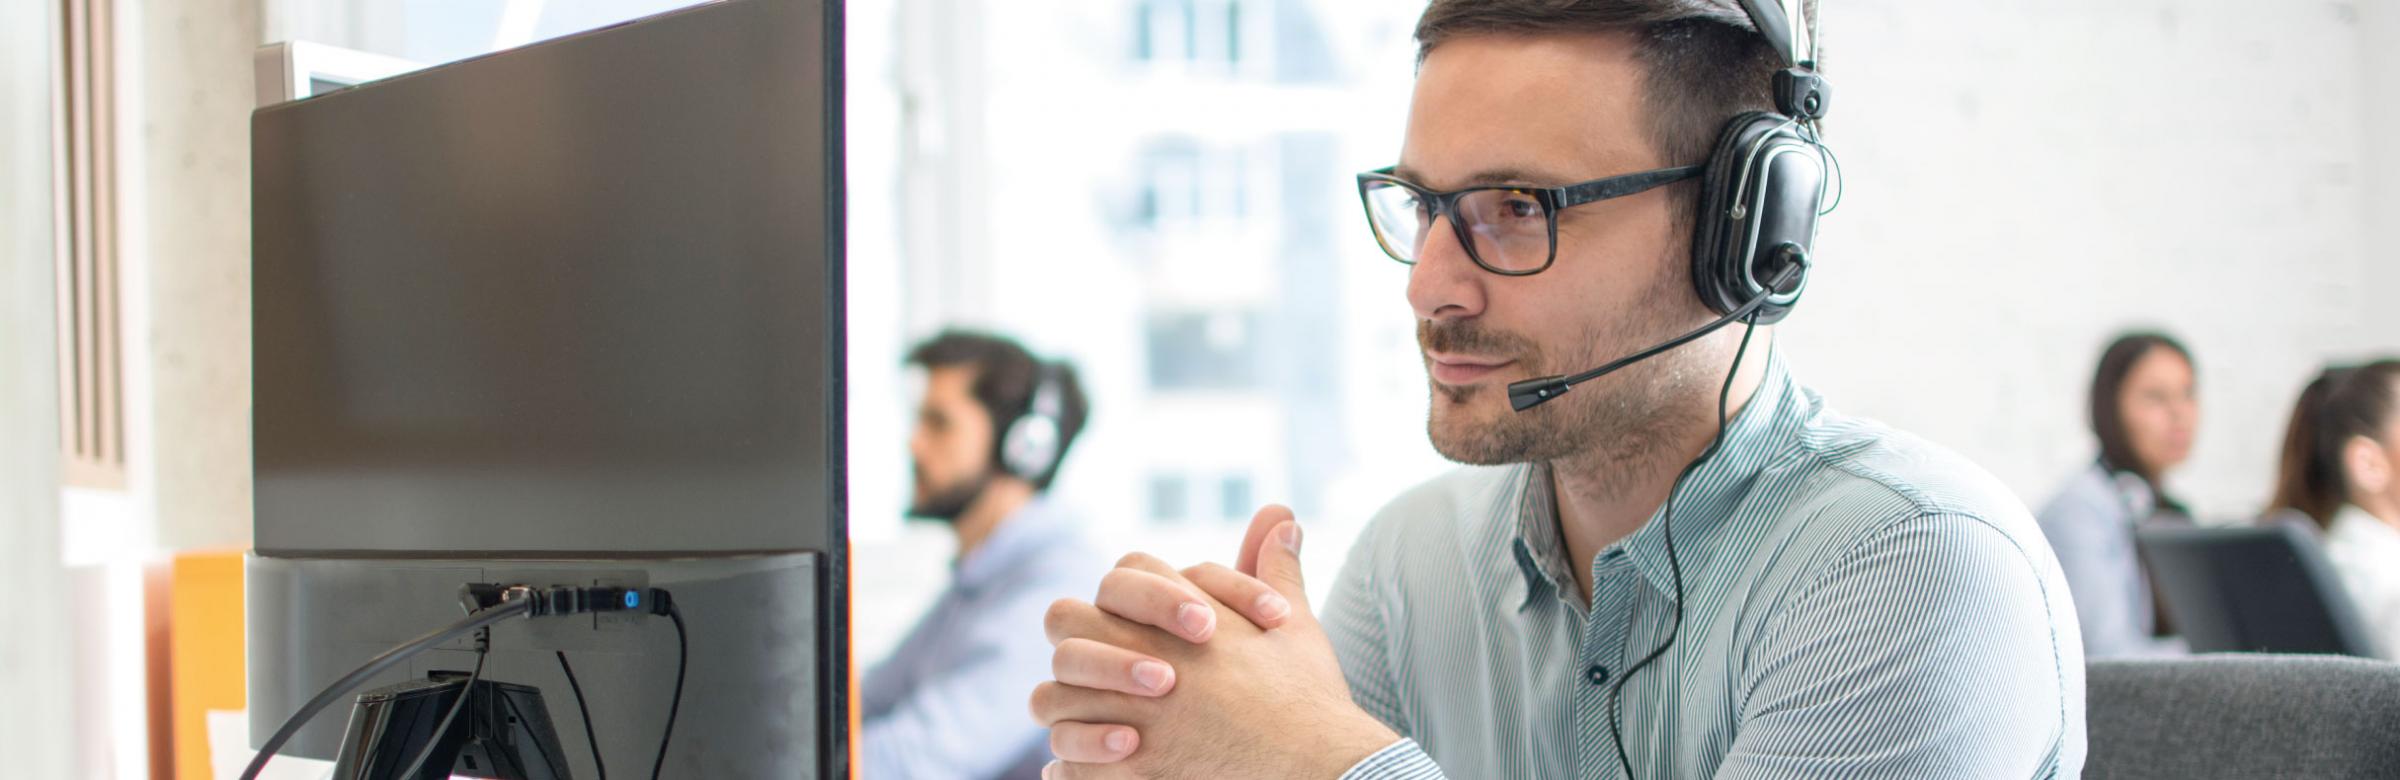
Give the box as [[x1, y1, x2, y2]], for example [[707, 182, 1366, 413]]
[[1032, 0, 2083, 778]]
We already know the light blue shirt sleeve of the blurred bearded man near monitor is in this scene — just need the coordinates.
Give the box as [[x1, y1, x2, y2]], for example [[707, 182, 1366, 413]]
[[859, 580, 1054, 780]]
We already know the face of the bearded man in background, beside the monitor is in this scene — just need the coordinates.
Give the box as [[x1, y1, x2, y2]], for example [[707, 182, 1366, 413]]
[[907, 365, 996, 521]]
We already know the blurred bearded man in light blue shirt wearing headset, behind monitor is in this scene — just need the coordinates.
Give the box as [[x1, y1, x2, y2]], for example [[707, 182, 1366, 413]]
[[859, 331, 1106, 780]]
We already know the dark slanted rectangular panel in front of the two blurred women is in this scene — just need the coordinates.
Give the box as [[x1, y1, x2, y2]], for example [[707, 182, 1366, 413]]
[[2136, 523, 2376, 658]]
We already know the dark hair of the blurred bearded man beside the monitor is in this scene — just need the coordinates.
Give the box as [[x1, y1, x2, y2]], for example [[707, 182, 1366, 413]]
[[907, 329, 1092, 490]]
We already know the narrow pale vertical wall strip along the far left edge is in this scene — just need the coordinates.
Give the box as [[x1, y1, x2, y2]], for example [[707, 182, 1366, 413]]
[[0, 2, 82, 778]]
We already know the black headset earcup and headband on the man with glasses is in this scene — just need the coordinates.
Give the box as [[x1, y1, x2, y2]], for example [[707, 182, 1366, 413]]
[[1692, 0, 1838, 324]]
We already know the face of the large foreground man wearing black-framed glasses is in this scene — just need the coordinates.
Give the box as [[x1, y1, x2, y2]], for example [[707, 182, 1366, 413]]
[[1397, 34, 1721, 463]]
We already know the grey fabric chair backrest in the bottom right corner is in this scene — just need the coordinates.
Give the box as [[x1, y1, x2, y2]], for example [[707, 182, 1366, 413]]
[[2083, 655, 2400, 780]]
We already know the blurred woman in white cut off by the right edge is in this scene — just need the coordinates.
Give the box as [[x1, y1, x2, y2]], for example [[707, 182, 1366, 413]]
[[2270, 360, 2400, 658]]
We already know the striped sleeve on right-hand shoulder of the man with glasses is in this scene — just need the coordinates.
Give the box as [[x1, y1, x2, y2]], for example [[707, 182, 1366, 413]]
[[1716, 514, 2083, 780]]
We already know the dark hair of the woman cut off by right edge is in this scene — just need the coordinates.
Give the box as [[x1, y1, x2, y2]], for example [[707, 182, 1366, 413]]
[[2270, 360, 2400, 526]]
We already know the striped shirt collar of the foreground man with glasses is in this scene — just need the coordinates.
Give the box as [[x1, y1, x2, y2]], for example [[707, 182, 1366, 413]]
[[1510, 348, 1812, 612]]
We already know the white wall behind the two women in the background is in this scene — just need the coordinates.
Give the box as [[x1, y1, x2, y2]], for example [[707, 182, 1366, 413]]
[[1786, 0, 2400, 518]]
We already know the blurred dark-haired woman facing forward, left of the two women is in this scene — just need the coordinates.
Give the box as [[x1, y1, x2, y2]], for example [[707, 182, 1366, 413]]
[[2038, 334, 2201, 658]]
